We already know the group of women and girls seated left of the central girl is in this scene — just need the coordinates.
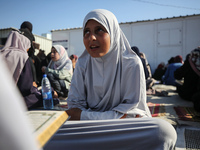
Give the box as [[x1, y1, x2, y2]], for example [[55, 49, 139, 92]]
[[1, 21, 78, 109]]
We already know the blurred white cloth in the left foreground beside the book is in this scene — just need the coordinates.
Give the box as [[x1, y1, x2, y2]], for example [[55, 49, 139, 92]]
[[0, 56, 39, 150]]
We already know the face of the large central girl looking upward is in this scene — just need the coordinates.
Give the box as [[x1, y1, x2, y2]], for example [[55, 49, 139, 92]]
[[83, 20, 110, 57]]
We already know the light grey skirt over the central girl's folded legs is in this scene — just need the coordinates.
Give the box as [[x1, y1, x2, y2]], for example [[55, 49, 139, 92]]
[[44, 117, 177, 150]]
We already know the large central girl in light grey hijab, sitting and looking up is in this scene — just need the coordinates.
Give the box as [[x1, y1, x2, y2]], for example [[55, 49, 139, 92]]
[[44, 9, 176, 150]]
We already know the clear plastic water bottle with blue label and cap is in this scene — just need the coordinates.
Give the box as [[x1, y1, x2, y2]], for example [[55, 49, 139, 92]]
[[42, 74, 54, 109]]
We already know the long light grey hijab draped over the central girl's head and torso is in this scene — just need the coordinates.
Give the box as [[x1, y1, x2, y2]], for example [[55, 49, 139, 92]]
[[68, 9, 150, 116]]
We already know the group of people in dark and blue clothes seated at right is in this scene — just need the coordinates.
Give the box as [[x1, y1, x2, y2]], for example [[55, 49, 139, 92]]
[[153, 50, 200, 112]]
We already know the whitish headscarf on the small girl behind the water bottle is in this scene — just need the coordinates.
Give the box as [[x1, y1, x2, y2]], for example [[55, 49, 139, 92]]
[[48, 45, 73, 74]]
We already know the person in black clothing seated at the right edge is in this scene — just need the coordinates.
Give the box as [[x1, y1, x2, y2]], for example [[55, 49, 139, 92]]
[[174, 48, 200, 105]]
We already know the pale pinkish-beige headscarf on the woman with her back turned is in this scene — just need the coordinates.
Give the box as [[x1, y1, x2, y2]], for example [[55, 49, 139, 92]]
[[1, 31, 31, 83]]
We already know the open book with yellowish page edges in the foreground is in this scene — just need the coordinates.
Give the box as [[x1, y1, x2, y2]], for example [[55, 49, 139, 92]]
[[27, 110, 69, 148]]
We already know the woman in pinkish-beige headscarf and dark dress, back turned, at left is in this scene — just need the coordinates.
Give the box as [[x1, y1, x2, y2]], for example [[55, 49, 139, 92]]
[[0, 30, 42, 109]]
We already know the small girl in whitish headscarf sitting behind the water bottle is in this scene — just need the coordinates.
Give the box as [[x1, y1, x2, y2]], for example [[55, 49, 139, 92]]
[[42, 45, 73, 97]]
